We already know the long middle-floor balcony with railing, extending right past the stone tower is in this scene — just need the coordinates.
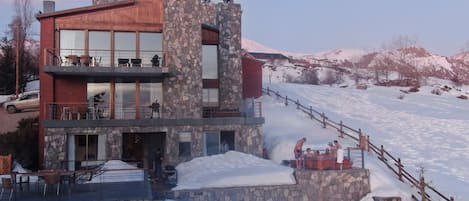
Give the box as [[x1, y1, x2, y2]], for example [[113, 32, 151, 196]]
[[43, 102, 264, 128]]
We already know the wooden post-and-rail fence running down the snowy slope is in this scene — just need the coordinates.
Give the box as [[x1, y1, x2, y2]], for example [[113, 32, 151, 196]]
[[262, 87, 454, 201]]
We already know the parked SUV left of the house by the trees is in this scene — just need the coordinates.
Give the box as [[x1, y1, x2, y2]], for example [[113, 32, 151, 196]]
[[3, 91, 39, 114]]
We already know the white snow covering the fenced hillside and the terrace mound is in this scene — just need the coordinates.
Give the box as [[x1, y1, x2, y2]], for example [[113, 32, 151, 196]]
[[175, 83, 469, 201]]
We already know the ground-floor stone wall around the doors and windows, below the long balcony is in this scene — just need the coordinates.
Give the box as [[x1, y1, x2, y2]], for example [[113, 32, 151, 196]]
[[44, 125, 263, 169]]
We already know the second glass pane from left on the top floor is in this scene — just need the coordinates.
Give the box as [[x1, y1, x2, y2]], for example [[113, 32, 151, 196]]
[[88, 31, 111, 67]]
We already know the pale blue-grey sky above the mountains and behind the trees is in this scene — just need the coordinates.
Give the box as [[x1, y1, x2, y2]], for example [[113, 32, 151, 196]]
[[0, 0, 469, 56]]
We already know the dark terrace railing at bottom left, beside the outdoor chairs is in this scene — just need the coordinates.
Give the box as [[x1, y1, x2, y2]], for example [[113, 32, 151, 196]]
[[11, 169, 152, 201]]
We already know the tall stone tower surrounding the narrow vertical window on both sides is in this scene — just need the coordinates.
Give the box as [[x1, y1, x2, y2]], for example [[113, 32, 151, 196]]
[[163, 0, 242, 118]]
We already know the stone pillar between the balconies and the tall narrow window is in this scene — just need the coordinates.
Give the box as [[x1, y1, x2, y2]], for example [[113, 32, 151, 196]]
[[163, 0, 202, 118]]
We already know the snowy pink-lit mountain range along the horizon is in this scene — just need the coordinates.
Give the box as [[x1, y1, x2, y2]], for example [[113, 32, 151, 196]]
[[242, 38, 469, 84]]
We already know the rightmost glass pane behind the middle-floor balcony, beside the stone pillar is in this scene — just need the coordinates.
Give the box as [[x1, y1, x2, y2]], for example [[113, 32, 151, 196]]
[[140, 83, 164, 118]]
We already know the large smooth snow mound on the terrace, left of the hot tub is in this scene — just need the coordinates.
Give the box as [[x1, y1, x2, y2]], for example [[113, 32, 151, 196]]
[[173, 151, 296, 190]]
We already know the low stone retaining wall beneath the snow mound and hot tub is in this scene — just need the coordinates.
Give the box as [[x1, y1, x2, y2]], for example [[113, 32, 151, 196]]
[[164, 169, 370, 201]]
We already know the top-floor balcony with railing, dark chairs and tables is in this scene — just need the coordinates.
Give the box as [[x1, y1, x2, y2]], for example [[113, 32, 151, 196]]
[[44, 49, 172, 78]]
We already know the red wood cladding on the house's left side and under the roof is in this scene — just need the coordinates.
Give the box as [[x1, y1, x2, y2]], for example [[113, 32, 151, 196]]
[[38, 0, 164, 164]]
